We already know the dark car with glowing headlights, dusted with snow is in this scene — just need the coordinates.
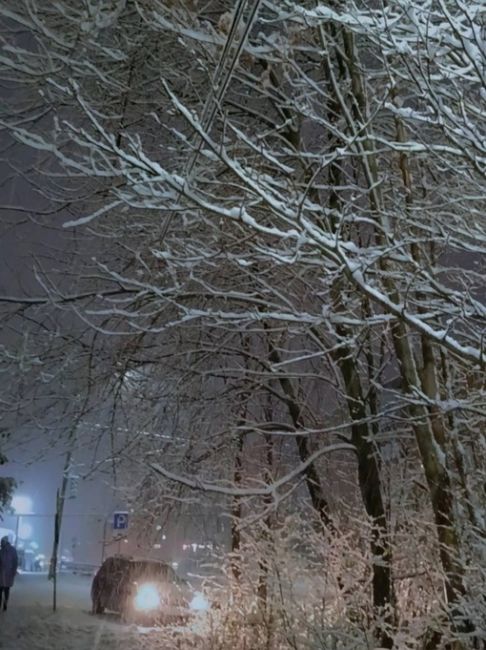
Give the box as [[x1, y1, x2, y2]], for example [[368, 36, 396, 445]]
[[91, 556, 206, 624]]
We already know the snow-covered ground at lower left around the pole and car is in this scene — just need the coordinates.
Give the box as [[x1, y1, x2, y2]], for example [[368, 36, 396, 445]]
[[0, 574, 201, 650]]
